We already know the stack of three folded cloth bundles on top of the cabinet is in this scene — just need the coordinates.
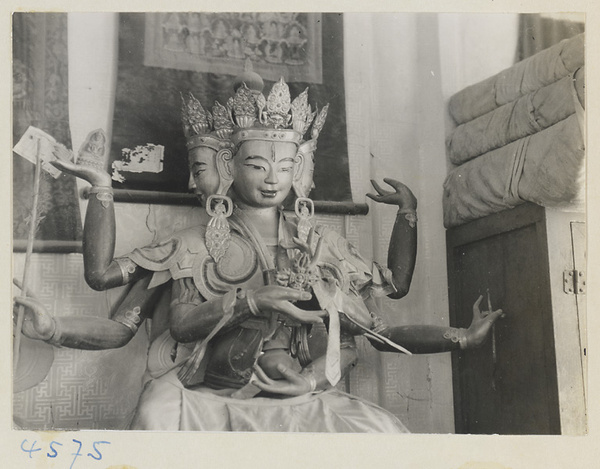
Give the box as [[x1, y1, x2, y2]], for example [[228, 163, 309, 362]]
[[443, 34, 585, 228]]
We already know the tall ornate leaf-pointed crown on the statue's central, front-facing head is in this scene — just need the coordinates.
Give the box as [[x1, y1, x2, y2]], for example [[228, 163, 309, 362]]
[[227, 62, 329, 145]]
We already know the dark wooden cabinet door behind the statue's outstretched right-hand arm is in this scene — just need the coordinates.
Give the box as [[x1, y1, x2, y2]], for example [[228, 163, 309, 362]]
[[447, 204, 560, 434]]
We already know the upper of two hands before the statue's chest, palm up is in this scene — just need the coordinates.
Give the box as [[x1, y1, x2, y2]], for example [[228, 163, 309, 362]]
[[254, 285, 327, 324]]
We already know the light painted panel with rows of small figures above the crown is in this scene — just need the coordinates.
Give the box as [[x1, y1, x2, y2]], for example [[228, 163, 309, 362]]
[[144, 13, 323, 83]]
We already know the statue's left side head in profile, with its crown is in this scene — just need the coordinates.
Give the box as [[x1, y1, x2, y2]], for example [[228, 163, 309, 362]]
[[181, 93, 232, 202]]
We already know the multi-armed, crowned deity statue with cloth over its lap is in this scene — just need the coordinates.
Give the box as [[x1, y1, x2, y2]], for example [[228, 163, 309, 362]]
[[16, 71, 502, 432]]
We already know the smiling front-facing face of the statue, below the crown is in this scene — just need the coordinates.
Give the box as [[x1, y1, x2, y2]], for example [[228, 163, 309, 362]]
[[233, 140, 297, 208]]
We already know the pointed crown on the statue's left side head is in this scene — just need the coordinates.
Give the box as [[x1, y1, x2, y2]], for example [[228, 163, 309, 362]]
[[181, 93, 233, 151]]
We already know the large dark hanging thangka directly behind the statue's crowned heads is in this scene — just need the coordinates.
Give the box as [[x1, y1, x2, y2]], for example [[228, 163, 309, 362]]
[[111, 13, 351, 201]]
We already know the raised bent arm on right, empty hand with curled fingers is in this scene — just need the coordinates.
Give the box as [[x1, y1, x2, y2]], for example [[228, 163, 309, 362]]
[[367, 178, 417, 299]]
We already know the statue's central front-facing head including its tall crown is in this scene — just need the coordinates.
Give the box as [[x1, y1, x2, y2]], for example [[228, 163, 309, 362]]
[[217, 65, 327, 208]]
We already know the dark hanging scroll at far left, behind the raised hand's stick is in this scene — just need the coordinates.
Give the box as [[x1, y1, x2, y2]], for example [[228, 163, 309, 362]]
[[12, 12, 81, 243]]
